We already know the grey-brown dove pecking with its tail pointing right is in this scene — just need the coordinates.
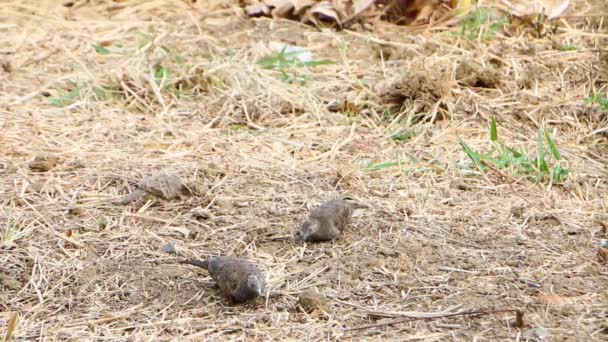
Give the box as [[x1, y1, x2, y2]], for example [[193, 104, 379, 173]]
[[295, 199, 369, 242]]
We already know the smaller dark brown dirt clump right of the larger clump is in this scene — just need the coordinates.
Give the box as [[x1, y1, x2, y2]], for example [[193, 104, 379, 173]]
[[456, 59, 500, 88]]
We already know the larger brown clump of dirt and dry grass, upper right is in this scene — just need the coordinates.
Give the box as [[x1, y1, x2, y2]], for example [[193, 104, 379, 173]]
[[376, 63, 452, 111]]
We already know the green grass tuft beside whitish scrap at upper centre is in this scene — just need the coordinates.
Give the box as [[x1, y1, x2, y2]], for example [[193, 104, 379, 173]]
[[256, 46, 335, 83]]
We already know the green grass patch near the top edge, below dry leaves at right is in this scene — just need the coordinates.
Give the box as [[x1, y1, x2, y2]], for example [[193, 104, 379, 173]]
[[458, 7, 509, 41]]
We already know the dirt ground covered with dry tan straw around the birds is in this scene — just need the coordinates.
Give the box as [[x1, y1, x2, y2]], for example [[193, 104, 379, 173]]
[[0, 0, 608, 341]]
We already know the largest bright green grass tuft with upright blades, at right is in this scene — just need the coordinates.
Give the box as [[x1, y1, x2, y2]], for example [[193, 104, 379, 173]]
[[458, 117, 571, 184]]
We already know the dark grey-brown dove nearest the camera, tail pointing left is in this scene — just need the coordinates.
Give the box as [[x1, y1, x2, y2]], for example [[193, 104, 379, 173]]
[[181, 256, 266, 303]]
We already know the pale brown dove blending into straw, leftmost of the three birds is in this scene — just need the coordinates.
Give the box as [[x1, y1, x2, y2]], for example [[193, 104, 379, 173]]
[[118, 173, 187, 205]]
